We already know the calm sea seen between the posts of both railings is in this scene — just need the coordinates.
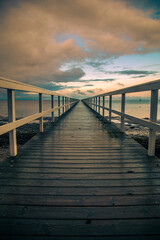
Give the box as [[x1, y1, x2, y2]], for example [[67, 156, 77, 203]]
[[0, 98, 160, 121]]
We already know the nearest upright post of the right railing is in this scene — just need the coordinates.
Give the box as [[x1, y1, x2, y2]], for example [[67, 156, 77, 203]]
[[148, 90, 158, 156]]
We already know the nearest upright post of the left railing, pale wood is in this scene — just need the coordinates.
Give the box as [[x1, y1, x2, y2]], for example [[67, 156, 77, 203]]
[[8, 89, 17, 156]]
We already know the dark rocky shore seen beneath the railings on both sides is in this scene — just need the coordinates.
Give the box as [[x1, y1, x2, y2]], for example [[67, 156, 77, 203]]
[[0, 117, 160, 162]]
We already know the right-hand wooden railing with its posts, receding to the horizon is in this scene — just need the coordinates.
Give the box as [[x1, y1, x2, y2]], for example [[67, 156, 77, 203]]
[[83, 80, 160, 156]]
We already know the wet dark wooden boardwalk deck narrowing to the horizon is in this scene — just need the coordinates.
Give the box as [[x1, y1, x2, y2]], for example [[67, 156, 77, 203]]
[[0, 102, 160, 240]]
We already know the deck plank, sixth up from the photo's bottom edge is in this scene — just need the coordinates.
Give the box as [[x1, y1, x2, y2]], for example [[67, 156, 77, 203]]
[[0, 178, 160, 188]]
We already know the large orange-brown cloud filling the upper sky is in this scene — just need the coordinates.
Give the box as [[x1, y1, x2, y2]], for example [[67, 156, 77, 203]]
[[0, 0, 160, 94]]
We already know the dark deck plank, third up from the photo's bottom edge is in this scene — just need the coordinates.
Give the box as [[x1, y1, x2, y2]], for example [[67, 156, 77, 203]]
[[0, 205, 160, 220]]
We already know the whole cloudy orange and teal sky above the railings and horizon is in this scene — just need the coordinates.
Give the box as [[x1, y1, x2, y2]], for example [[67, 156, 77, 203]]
[[0, 0, 160, 99]]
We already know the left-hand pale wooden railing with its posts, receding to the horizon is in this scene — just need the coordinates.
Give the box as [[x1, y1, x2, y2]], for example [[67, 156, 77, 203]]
[[0, 77, 79, 156]]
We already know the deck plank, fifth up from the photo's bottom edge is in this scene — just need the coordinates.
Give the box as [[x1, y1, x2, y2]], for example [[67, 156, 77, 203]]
[[0, 186, 160, 197]]
